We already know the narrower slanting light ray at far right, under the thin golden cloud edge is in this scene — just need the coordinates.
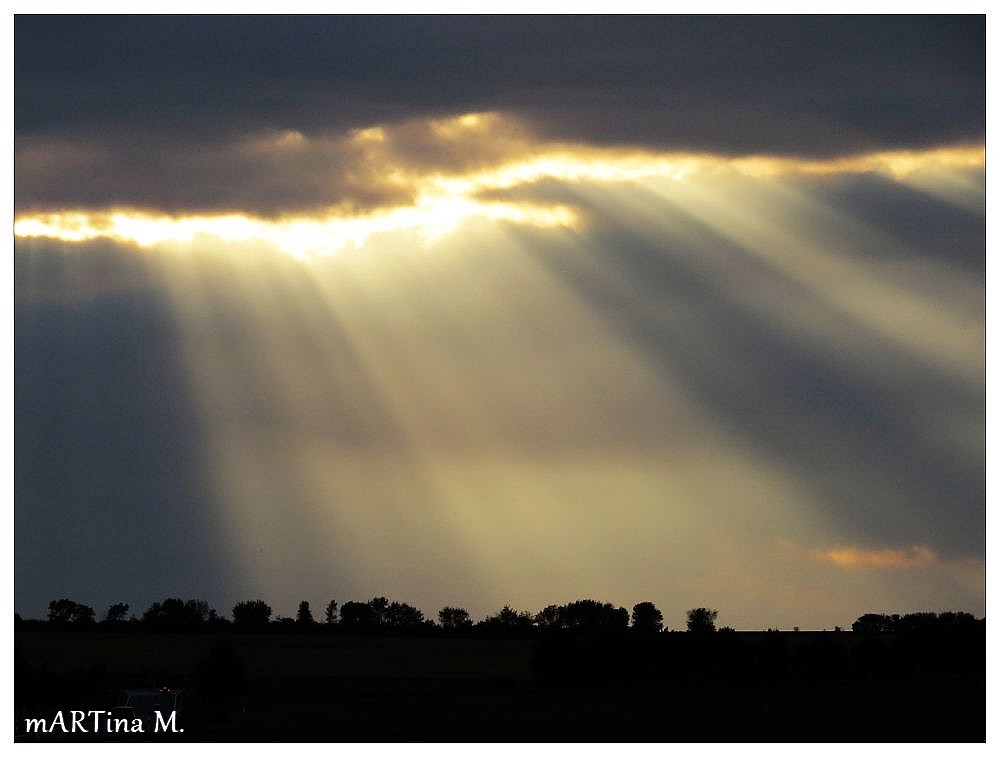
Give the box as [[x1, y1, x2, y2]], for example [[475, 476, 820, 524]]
[[640, 171, 981, 381]]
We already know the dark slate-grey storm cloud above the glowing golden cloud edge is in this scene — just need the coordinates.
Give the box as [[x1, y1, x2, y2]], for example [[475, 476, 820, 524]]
[[15, 16, 985, 214]]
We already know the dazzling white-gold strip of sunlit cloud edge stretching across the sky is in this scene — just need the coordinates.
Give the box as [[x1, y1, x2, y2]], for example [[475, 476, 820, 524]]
[[14, 114, 985, 257]]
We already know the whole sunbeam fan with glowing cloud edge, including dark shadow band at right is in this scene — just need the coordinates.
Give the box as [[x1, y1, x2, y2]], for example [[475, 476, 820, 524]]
[[15, 116, 984, 626]]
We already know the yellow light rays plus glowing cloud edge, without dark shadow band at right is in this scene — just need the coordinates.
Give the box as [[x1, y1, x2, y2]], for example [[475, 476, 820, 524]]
[[15, 133, 981, 624]]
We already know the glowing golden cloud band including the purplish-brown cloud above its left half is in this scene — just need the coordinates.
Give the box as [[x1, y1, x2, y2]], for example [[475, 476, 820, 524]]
[[14, 113, 985, 256]]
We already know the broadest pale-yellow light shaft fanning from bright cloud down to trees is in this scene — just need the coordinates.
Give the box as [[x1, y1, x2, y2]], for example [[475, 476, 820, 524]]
[[141, 213, 852, 613]]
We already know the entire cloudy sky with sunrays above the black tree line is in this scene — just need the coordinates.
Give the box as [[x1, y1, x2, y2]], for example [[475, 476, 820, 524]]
[[14, 16, 986, 628]]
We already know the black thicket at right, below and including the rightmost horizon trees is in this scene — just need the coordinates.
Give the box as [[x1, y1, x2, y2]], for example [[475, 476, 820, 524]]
[[533, 608, 986, 683]]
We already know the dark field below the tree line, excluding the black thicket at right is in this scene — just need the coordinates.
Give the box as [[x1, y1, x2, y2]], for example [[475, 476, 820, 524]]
[[15, 631, 985, 741]]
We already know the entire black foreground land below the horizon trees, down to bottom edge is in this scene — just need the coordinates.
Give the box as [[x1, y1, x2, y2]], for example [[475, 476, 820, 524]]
[[15, 629, 986, 741]]
